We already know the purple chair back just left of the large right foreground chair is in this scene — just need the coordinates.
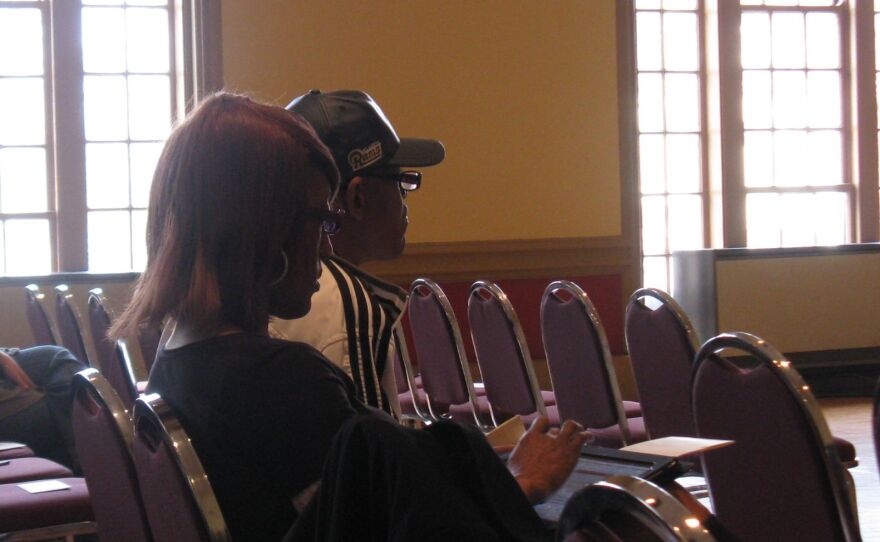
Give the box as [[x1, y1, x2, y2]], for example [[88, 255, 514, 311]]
[[625, 288, 699, 438]]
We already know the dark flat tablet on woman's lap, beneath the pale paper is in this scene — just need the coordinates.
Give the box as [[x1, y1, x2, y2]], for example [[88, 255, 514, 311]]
[[535, 446, 691, 525]]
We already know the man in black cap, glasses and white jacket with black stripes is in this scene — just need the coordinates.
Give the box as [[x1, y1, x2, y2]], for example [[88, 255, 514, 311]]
[[270, 90, 445, 414]]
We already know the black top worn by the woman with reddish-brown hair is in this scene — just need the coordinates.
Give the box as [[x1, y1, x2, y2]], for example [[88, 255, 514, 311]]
[[147, 333, 368, 542]]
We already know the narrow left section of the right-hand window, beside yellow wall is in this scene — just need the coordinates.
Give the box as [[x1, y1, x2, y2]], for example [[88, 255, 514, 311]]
[[635, 0, 705, 290]]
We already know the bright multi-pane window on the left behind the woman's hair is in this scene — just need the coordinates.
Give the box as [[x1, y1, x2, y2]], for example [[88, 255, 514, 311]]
[[0, 0, 219, 275]]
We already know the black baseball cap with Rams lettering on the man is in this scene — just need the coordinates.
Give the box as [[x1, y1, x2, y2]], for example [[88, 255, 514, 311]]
[[287, 90, 446, 180]]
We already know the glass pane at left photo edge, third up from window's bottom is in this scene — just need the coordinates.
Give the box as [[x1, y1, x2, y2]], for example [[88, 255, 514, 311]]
[[0, 78, 46, 145]]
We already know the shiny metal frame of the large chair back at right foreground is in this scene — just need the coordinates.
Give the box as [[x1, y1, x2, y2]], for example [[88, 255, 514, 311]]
[[691, 332, 861, 541]]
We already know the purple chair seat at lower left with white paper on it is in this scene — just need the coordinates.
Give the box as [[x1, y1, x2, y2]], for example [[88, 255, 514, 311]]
[[0, 478, 93, 533]]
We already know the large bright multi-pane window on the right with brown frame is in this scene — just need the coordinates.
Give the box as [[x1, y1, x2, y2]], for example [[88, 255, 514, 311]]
[[633, 0, 880, 289]]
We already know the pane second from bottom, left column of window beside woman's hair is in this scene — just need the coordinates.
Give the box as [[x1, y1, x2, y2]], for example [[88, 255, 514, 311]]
[[86, 143, 129, 209]]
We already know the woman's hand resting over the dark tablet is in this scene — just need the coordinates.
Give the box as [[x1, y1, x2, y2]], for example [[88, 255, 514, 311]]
[[507, 416, 590, 504]]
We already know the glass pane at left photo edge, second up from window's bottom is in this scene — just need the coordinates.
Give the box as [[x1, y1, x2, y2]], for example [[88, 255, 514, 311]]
[[0, 147, 48, 213]]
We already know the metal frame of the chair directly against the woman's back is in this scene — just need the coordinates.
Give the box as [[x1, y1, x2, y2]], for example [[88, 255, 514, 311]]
[[134, 393, 232, 542]]
